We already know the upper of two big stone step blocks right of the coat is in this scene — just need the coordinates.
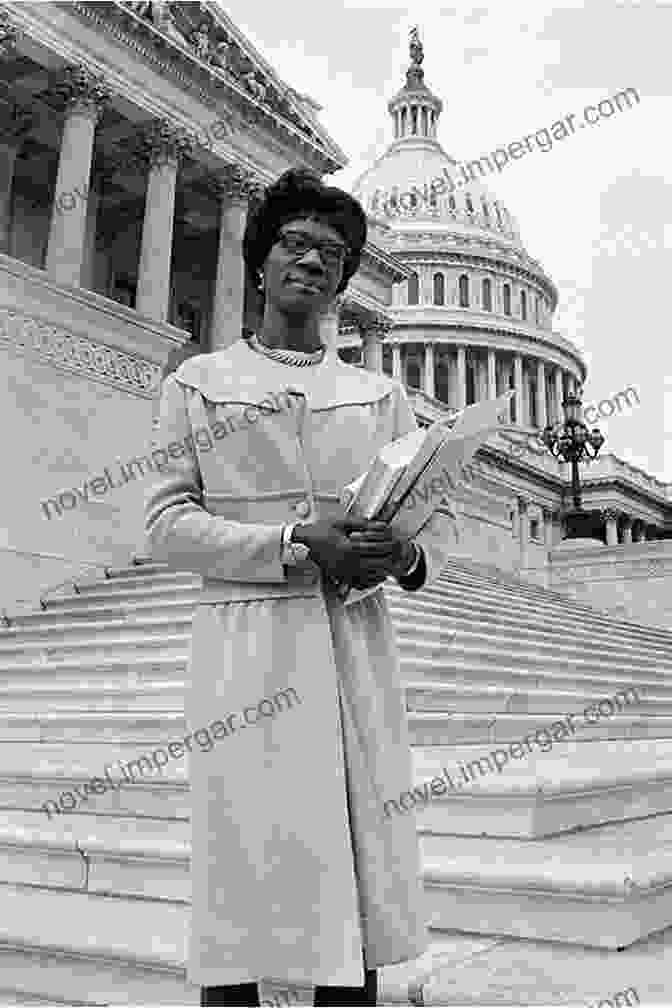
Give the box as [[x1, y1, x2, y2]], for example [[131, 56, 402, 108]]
[[405, 732, 672, 838]]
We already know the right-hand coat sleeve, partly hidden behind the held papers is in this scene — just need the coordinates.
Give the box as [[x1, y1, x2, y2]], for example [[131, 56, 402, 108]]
[[394, 384, 459, 592]]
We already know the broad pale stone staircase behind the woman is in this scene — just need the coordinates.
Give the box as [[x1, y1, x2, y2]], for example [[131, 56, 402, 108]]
[[0, 561, 672, 1005]]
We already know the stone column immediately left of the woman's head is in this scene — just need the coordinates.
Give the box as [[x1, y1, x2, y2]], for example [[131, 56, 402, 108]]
[[209, 164, 257, 351]]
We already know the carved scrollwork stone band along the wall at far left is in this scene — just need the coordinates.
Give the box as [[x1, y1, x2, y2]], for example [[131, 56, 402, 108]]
[[0, 307, 161, 398]]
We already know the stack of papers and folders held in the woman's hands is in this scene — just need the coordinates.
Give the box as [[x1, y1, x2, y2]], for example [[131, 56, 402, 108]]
[[339, 389, 515, 602]]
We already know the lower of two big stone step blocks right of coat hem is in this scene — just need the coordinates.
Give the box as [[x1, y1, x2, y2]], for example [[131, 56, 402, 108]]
[[420, 814, 672, 950]]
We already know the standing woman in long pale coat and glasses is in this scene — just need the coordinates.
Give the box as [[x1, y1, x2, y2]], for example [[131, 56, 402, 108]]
[[146, 169, 463, 1005]]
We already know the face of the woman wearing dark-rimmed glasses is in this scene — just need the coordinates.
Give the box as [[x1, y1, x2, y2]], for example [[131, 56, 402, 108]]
[[264, 218, 347, 316]]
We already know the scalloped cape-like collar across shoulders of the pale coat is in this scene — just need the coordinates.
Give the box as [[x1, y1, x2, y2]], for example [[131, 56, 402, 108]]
[[173, 338, 396, 409]]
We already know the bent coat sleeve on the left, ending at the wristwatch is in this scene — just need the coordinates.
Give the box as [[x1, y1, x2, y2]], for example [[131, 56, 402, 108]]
[[145, 375, 287, 583]]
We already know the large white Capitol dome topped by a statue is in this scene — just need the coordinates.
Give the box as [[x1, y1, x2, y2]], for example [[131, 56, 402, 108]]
[[344, 28, 586, 429]]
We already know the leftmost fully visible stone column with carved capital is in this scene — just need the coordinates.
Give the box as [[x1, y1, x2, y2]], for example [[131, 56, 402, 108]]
[[44, 67, 110, 287]]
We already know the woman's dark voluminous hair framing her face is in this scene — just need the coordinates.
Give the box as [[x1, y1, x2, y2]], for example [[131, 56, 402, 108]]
[[243, 168, 367, 294]]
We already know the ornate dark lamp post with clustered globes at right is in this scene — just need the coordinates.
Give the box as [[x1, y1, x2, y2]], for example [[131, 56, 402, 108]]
[[541, 395, 604, 539]]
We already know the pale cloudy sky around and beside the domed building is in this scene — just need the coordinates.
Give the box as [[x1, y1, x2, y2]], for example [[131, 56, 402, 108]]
[[221, 0, 672, 481]]
